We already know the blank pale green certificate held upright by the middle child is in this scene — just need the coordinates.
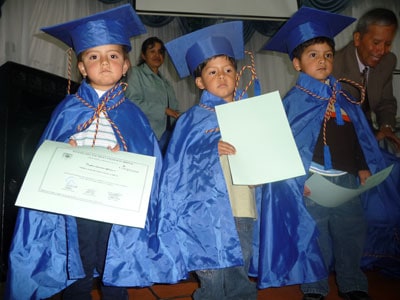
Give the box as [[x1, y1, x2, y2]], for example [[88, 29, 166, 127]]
[[215, 91, 305, 185]]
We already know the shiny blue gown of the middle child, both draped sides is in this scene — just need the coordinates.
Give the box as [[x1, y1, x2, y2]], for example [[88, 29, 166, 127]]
[[160, 91, 326, 288]]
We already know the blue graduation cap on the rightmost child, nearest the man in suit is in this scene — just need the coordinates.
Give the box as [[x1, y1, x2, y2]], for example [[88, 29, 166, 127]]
[[262, 7, 356, 59]]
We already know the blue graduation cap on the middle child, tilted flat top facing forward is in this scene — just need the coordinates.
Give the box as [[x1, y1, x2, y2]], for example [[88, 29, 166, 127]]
[[165, 21, 244, 78]]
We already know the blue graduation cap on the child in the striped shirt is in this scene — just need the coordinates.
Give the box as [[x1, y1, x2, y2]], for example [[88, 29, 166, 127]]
[[41, 4, 146, 55]]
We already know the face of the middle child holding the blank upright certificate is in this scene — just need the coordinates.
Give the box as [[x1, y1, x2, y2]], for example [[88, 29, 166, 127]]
[[196, 56, 236, 102]]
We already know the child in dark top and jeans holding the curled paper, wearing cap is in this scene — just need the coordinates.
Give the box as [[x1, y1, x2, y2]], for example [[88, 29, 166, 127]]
[[265, 8, 396, 300]]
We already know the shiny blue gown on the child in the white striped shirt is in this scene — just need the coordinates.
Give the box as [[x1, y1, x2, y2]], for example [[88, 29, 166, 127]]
[[6, 81, 186, 299]]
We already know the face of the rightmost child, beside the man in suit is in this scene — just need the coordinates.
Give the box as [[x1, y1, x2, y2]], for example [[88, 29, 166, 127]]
[[293, 43, 333, 82]]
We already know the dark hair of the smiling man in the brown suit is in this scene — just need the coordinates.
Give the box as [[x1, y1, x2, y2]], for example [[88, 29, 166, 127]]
[[354, 8, 398, 34]]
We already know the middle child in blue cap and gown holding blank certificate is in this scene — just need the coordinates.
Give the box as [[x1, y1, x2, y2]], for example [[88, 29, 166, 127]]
[[160, 22, 257, 300]]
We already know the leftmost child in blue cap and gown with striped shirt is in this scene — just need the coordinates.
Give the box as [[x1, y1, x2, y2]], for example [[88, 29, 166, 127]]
[[6, 5, 186, 300]]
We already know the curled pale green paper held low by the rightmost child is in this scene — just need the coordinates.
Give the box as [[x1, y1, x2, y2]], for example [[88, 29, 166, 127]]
[[306, 165, 393, 207]]
